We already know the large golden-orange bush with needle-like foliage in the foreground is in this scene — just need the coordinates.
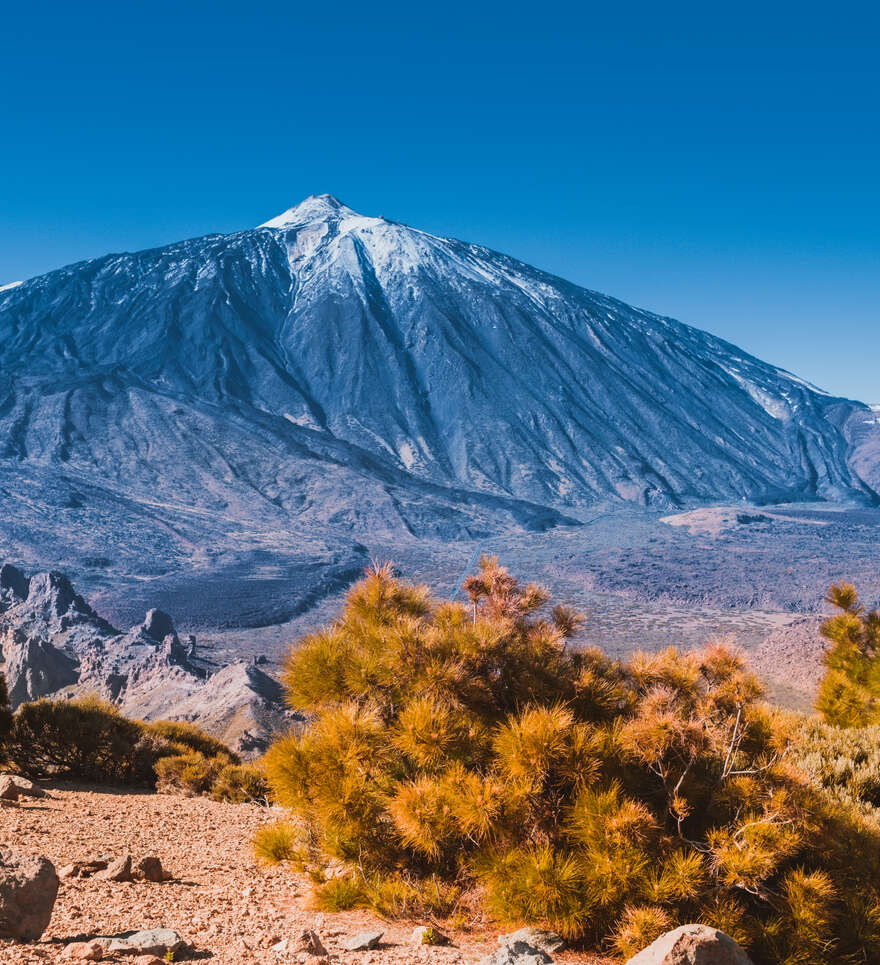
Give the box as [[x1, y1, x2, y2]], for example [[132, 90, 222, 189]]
[[265, 559, 880, 965]]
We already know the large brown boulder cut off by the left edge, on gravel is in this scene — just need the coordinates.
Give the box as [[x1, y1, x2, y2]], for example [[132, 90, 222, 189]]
[[0, 850, 58, 942]]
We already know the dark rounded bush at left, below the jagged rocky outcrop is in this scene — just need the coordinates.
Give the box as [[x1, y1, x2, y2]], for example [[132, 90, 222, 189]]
[[6, 698, 156, 786]]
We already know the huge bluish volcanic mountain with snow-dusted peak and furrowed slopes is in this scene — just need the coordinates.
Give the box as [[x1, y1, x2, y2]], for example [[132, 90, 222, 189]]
[[0, 195, 880, 620]]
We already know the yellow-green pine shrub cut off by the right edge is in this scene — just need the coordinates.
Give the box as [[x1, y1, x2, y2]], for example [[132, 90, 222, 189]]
[[816, 583, 880, 727]]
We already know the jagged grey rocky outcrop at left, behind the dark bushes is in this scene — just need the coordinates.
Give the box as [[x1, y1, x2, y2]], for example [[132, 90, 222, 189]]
[[0, 564, 291, 756]]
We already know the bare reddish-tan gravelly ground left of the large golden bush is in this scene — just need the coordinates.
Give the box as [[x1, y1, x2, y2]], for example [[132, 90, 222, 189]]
[[0, 785, 607, 965]]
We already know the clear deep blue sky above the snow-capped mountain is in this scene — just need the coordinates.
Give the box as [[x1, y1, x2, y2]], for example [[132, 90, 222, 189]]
[[0, 0, 880, 402]]
